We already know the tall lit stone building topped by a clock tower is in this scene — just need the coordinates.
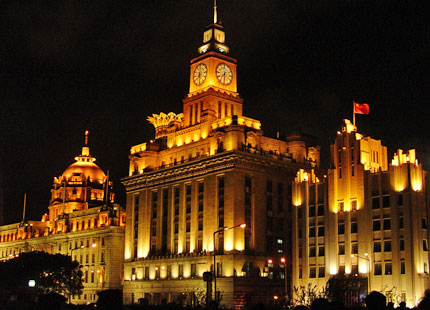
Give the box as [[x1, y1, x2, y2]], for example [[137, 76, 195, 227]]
[[123, 4, 319, 308]]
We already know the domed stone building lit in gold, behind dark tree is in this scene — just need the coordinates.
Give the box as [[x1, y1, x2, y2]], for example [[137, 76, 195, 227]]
[[0, 132, 125, 303]]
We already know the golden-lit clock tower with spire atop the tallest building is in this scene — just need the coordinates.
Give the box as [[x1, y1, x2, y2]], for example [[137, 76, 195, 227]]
[[183, 2, 243, 127]]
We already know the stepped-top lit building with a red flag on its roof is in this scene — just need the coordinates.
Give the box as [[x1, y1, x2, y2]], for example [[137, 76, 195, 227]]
[[292, 120, 430, 306]]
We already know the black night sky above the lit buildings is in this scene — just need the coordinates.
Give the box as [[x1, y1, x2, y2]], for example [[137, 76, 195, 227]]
[[0, 0, 430, 222]]
